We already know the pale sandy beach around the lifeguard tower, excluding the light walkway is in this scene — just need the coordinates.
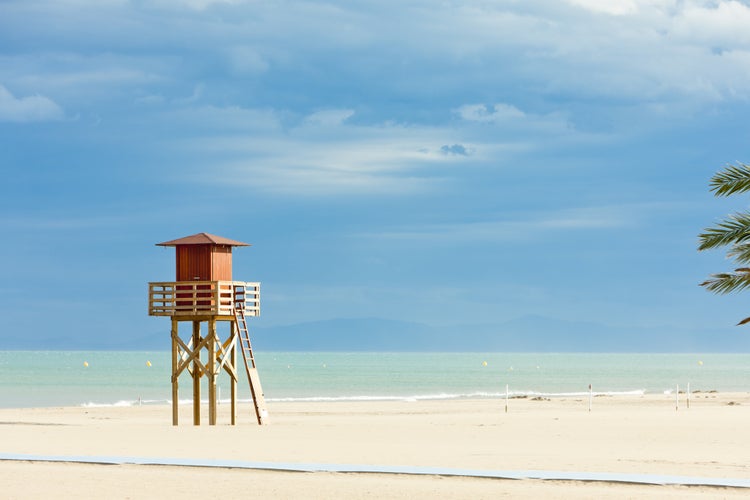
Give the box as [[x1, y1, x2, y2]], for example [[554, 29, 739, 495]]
[[0, 393, 750, 499]]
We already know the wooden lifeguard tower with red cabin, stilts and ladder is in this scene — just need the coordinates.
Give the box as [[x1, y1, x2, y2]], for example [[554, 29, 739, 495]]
[[148, 233, 268, 425]]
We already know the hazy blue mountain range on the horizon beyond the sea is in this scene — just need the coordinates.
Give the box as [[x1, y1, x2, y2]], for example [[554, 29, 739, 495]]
[[7, 315, 750, 352]]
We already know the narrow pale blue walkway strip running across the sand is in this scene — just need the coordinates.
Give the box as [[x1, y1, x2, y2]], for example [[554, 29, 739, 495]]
[[0, 453, 750, 488]]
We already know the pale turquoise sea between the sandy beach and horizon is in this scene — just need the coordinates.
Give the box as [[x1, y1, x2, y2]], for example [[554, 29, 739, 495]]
[[0, 351, 750, 408]]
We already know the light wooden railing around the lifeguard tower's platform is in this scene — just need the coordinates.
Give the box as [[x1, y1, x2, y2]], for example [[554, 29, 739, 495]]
[[148, 281, 260, 316]]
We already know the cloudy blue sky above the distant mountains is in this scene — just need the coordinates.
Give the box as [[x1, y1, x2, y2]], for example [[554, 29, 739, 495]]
[[0, 0, 750, 345]]
